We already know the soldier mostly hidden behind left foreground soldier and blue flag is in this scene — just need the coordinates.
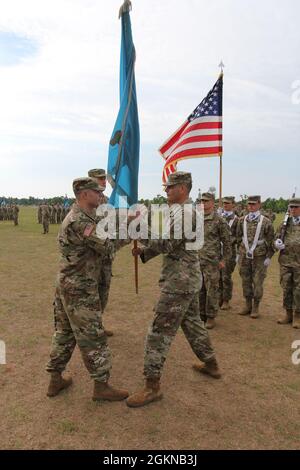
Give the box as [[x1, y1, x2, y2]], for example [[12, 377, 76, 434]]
[[88, 168, 115, 336]]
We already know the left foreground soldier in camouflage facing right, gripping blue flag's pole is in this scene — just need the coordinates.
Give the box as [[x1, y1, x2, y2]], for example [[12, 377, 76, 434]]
[[47, 178, 128, 401]]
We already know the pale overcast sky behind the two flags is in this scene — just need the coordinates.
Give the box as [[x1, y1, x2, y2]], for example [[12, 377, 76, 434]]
[[0, 0, 300, 198]]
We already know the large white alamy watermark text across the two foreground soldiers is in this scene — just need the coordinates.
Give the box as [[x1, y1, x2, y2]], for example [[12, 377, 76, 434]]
[[96, 203, 204, 250]]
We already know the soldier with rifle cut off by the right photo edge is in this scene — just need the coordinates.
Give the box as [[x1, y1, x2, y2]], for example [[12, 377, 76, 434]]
[[275, 198, 300, 328]]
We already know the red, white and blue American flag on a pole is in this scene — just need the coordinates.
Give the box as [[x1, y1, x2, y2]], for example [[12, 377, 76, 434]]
[[159, 73, 223, 183]]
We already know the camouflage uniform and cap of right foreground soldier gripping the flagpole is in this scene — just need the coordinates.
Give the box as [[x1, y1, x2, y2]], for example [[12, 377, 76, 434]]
[[137, 172, 215, 379]]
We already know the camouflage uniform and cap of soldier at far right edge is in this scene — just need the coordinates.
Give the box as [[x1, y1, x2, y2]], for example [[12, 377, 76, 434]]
[[276, 199, 300, 319]]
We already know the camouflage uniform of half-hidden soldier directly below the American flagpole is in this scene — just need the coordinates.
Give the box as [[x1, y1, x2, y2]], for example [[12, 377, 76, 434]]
[[220, 198, 239, 305]]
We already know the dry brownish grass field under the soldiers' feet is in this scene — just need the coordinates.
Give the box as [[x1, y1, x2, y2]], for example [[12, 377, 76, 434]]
[[0, 208, 300, 450]]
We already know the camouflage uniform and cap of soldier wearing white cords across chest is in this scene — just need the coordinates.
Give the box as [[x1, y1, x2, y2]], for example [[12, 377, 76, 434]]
[[237, 196, 274, 305]]
